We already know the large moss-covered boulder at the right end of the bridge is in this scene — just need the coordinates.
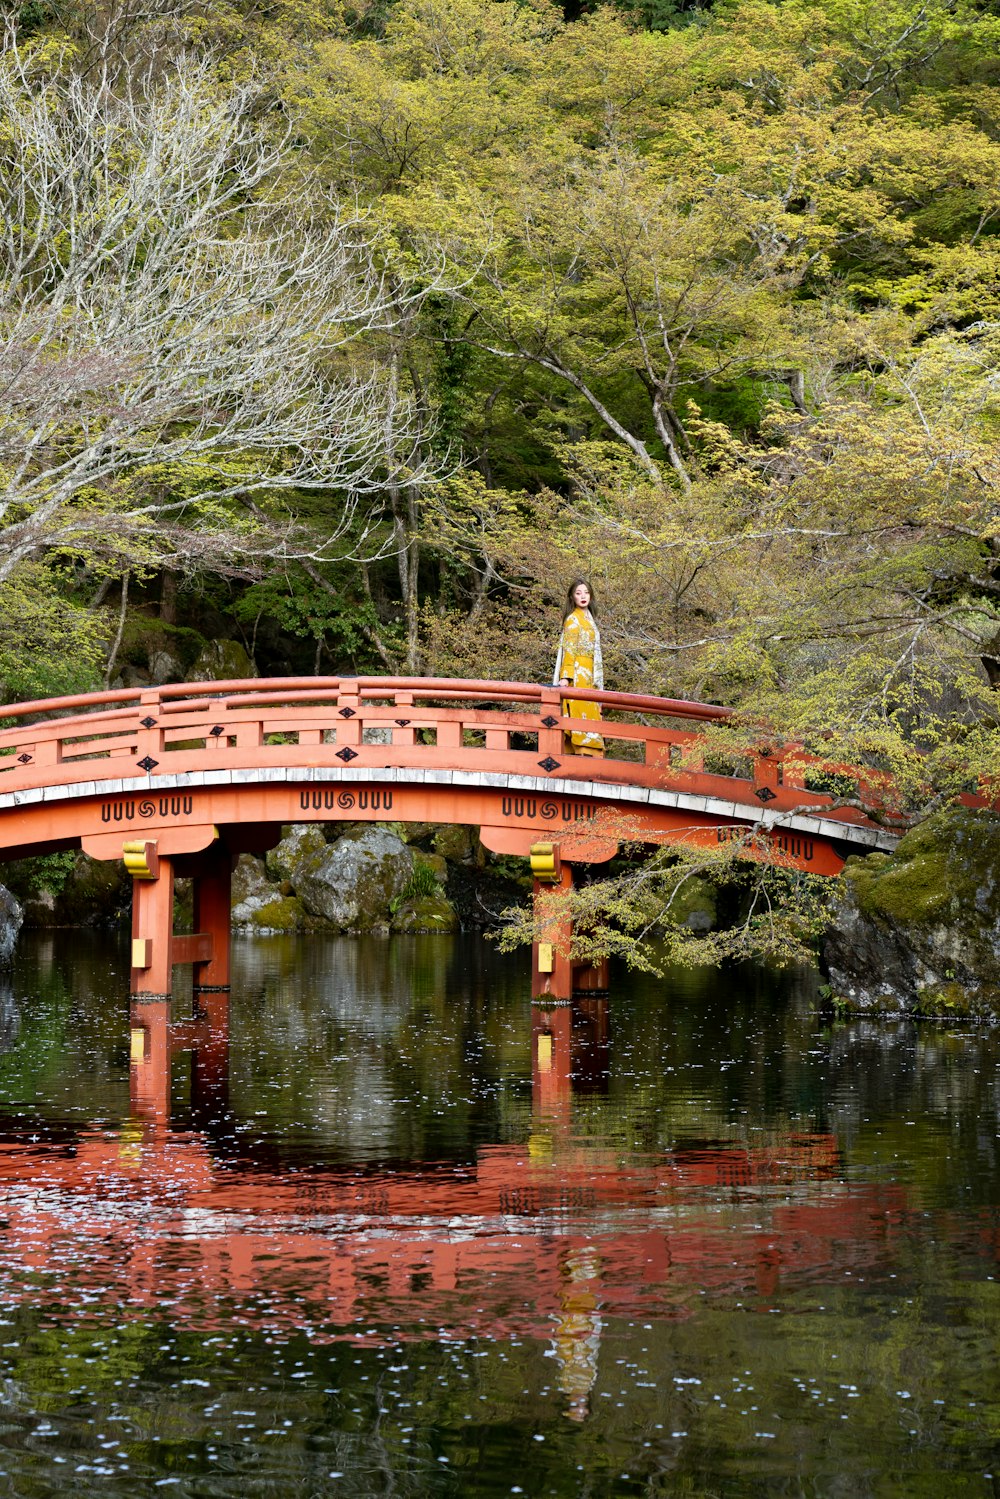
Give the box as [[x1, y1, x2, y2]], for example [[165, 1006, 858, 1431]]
[[823, 808, 1000, 1015]]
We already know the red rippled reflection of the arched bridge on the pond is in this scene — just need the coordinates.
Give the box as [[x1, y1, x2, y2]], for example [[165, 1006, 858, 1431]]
[[0, 971, 903, 1421]]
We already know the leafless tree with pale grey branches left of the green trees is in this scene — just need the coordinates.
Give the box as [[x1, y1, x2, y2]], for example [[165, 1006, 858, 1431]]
[[0, 48, 437, 632]]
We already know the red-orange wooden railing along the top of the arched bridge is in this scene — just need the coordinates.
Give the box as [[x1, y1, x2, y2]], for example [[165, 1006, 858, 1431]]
[[0, 676, 885, 821]]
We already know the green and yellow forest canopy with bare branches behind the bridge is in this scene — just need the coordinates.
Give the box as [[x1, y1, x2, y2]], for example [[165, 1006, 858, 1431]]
[[0, 0, 1000, 806]]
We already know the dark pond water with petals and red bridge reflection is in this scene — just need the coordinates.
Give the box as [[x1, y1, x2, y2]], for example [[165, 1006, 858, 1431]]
[[0, 932, 1000, 1499]]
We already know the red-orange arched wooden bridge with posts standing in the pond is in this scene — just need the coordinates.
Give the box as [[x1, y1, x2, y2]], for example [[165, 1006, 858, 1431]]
[[0, 678, 897, 997]]
